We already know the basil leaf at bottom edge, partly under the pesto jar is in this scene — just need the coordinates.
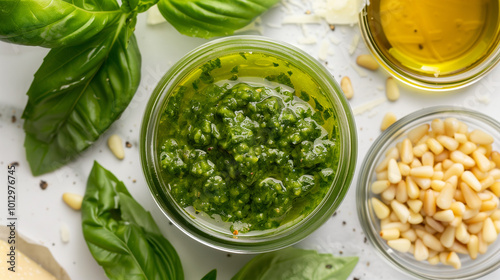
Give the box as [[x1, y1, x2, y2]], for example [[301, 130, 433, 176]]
[[232, 247, 358, 280]]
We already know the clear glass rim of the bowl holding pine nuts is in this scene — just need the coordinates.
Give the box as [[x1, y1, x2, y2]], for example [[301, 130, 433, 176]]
[[356, 106, 500, 280]]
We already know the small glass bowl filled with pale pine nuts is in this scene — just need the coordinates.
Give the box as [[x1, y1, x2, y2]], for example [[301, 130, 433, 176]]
[[356, 107, 500, 279]]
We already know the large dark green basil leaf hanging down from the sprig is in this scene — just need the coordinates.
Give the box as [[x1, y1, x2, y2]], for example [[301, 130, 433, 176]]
[[23, 19, 141, 176]]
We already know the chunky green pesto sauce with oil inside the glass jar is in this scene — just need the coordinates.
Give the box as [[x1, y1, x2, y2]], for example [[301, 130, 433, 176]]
[[158, 53, 340, 233]]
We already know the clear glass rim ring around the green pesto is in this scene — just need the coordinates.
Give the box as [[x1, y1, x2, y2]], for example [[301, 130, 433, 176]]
[[140, 35, 357, 253]]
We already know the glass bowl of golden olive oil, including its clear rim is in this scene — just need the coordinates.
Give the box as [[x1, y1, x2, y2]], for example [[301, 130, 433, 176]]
[[360, 0, 500, 91]]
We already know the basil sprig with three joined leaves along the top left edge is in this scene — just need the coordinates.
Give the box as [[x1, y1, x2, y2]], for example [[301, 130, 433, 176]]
[[0, 0, 279, 176]]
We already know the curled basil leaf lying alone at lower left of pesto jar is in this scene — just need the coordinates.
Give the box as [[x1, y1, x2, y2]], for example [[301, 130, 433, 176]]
[[82, 162, 184, 280]]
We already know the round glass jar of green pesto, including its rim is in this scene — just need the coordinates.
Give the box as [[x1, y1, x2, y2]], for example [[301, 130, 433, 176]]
[[140, 36, 357, 253]]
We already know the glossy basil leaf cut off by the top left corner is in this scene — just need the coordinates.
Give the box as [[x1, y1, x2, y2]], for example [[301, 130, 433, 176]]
[[0, 0, 122, 48]]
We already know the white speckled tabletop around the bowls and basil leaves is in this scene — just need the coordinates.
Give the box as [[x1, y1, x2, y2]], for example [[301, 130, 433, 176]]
[[0, 2, 500, 280]]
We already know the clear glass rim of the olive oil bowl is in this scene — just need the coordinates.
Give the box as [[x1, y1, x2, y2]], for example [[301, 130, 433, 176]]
[[358, 3, 500, 92]]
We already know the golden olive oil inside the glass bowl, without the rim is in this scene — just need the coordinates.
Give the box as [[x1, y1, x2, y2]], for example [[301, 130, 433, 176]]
[[368, 0, 499, 77]]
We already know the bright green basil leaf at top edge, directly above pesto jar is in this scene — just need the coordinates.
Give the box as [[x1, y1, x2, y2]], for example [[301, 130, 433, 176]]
[[158, 0, 279, 38]]
